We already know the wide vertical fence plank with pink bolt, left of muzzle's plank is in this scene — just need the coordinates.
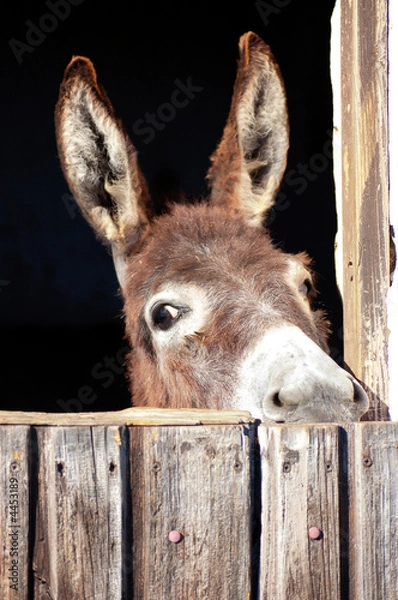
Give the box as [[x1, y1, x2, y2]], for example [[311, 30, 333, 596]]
[[131, 425, 252, 600]]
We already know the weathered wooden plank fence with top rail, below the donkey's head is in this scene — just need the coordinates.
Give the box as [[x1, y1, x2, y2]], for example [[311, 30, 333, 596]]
[[0, 409, 398, 600]]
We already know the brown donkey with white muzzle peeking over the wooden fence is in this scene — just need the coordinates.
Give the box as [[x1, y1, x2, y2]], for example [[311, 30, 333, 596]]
[[55, 32, 368, 423]]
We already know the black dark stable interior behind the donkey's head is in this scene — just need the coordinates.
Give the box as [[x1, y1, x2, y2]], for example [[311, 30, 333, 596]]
[[0, 0, 342, 411]]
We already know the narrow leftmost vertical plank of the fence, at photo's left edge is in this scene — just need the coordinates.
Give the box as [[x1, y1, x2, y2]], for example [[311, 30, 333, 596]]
[[0, 425, 30, 600]]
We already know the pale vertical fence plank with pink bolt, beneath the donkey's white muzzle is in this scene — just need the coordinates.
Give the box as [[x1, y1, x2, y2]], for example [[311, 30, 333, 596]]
[[258, 425, 341, 600]]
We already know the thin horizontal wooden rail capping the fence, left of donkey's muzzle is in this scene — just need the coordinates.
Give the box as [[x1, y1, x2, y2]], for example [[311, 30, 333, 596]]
[[0, 407, 254, 427]]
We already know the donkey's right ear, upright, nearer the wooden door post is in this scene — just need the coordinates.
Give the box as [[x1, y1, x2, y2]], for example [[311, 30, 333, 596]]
[[207, 32, 289, 225]]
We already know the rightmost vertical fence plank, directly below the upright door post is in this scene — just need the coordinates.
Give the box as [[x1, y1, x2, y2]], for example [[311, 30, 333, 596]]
[[346, 423, 398, 600]]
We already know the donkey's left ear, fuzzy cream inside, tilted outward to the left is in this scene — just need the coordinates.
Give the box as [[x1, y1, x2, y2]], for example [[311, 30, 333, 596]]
[[55, 56, 150, 274]]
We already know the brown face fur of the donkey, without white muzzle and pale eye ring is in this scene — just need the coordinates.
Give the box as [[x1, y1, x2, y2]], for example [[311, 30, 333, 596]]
[[125, 204, 328, 408]]
